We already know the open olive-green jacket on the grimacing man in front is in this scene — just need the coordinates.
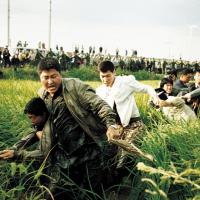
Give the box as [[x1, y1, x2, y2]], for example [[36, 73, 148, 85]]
[[38, 78, 116, 146]]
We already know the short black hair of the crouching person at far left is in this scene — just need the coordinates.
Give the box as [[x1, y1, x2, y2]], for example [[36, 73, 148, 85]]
[[24, 97, 48, 116]]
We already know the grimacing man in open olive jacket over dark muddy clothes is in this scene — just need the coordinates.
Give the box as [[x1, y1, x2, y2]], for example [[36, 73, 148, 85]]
[[38, 58, 119, 199]]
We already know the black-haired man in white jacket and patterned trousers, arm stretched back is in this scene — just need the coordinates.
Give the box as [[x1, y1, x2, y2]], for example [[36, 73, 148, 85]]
[[96, 61, 159, 170]]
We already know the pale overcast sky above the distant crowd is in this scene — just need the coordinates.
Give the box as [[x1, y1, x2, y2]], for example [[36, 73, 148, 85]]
[[0, 0, 200, 60]]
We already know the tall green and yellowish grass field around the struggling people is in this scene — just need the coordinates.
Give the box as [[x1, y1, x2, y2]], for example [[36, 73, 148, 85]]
[[0, 80, 200, 200]]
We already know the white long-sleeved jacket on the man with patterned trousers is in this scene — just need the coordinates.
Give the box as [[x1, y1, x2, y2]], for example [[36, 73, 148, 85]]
[[96, 75, 158, 127]]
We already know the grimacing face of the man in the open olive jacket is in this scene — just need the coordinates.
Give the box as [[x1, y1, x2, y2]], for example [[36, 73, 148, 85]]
[[40, 69, 62, 96]]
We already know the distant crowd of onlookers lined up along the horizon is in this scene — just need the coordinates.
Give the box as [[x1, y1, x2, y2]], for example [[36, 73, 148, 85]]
[[0, 41, 200, 74]]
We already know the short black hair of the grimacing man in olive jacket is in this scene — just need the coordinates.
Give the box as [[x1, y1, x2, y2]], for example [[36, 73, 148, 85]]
[[37, 58, 61, 74]]
